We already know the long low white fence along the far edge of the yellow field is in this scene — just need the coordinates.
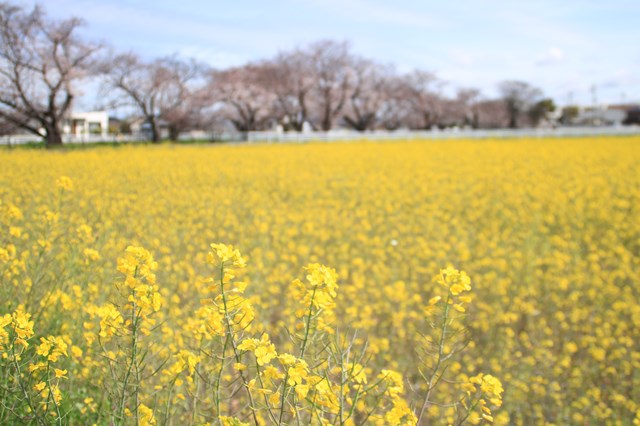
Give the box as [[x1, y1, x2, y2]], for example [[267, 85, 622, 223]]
[[0, 126, 640, 145]]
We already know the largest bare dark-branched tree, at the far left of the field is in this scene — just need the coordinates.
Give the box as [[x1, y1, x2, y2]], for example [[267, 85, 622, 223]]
[[0, 2, 101, 147]]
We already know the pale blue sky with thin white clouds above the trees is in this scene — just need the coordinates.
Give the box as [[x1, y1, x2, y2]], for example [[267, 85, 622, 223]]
[[14, 0, 640, 104]]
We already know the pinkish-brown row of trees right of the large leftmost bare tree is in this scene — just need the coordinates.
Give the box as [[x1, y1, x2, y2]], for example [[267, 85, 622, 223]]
[[101, 40, 554, 140]]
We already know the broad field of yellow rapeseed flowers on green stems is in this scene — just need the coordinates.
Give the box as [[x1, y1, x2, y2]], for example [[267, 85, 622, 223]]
[[0, 137, 640, 425]]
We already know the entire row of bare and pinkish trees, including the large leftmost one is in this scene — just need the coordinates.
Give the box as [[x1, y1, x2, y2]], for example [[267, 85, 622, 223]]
[[0, 2, 553, 145]]
